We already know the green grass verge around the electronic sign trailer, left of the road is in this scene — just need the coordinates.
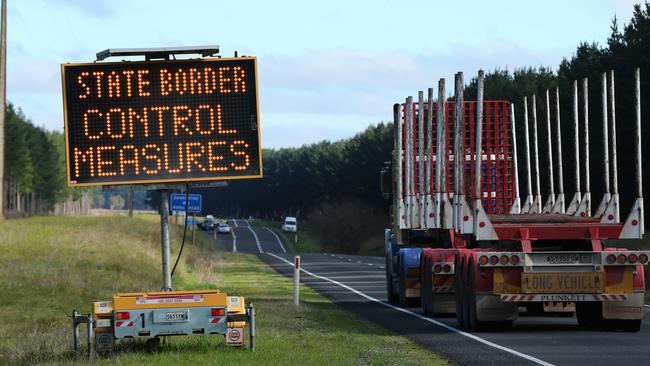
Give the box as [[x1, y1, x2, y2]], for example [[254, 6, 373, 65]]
[[0, 216, 448, 365]]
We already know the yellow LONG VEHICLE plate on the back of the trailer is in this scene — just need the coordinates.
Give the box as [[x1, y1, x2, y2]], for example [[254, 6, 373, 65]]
[[521, 272, 604, 294]]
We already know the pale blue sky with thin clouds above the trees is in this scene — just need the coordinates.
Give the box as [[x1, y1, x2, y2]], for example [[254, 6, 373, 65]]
[[7, 0, 637, 148]]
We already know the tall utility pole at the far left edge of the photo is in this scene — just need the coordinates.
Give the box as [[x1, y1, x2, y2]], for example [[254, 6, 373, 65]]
[[0, 0, 7, 221]]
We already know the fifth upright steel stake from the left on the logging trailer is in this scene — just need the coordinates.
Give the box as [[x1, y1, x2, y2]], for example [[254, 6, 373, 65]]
[[434, 79, 446, 228]]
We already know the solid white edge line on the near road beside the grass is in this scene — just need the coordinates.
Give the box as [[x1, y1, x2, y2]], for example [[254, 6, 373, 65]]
[[267, 253, 553, 366]]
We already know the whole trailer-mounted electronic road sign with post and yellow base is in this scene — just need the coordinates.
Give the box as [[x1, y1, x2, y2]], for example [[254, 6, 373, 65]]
[[67, 46, 262, 355]]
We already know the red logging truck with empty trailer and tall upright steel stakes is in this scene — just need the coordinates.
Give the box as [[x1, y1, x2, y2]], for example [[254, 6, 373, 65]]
[[382, 69, 650, 332]]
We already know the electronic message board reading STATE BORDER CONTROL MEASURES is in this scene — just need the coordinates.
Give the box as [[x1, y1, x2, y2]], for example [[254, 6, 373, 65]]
[[61, 57, 262, 186]]
